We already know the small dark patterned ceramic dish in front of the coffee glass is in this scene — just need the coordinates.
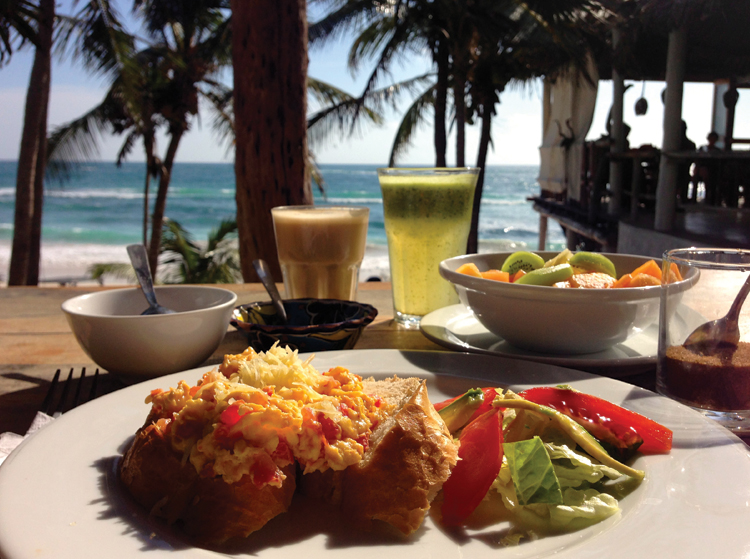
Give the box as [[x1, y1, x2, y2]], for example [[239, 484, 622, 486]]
[[230, 299, 378, 353]]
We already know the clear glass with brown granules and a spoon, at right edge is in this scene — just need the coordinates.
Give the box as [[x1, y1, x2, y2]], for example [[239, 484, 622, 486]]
[[656, 248, 750, 434]]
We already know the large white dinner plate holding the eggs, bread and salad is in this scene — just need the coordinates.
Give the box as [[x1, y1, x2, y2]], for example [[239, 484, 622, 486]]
[[0, 350, 750, 559]]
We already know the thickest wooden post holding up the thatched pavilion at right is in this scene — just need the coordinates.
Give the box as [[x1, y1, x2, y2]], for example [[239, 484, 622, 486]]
[[654, 29, 687, 231]]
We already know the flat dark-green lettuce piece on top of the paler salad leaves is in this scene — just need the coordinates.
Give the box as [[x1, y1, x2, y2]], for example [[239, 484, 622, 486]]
[[503, 437, 563, 505]]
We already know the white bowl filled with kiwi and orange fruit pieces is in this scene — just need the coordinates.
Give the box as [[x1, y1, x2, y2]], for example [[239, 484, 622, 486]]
[[440, 251, 697, 355]]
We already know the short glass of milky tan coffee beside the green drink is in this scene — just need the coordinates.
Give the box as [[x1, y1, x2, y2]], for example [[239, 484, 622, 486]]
[[271, 206, 370, 301]]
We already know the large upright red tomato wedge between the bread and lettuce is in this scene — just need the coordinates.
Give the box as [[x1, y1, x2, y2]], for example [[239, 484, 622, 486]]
[[442, 408, 503, 526]]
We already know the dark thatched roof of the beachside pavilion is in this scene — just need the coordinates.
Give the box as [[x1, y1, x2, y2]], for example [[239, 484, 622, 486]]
[[605, 0, 750, 82]]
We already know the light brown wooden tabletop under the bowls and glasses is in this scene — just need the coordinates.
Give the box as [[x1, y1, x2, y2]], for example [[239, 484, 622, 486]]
[[0, 282, 445, 433]]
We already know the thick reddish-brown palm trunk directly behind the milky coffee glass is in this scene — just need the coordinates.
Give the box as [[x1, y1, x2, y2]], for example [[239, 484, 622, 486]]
[[231, 0, 313, 281]]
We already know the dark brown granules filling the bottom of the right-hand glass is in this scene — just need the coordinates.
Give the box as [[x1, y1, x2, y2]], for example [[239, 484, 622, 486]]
[[659, 342, 750, 411]]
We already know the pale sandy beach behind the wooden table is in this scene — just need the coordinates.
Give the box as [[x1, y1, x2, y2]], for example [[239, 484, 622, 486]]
[[0, 241, 390, 285]]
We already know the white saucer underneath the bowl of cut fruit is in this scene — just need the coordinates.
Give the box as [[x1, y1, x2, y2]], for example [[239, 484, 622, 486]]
[[420, 304, 659, 377]]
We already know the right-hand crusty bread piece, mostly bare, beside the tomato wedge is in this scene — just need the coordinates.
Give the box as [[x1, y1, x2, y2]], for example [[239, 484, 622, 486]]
[[298, 377, 458, 535]]
